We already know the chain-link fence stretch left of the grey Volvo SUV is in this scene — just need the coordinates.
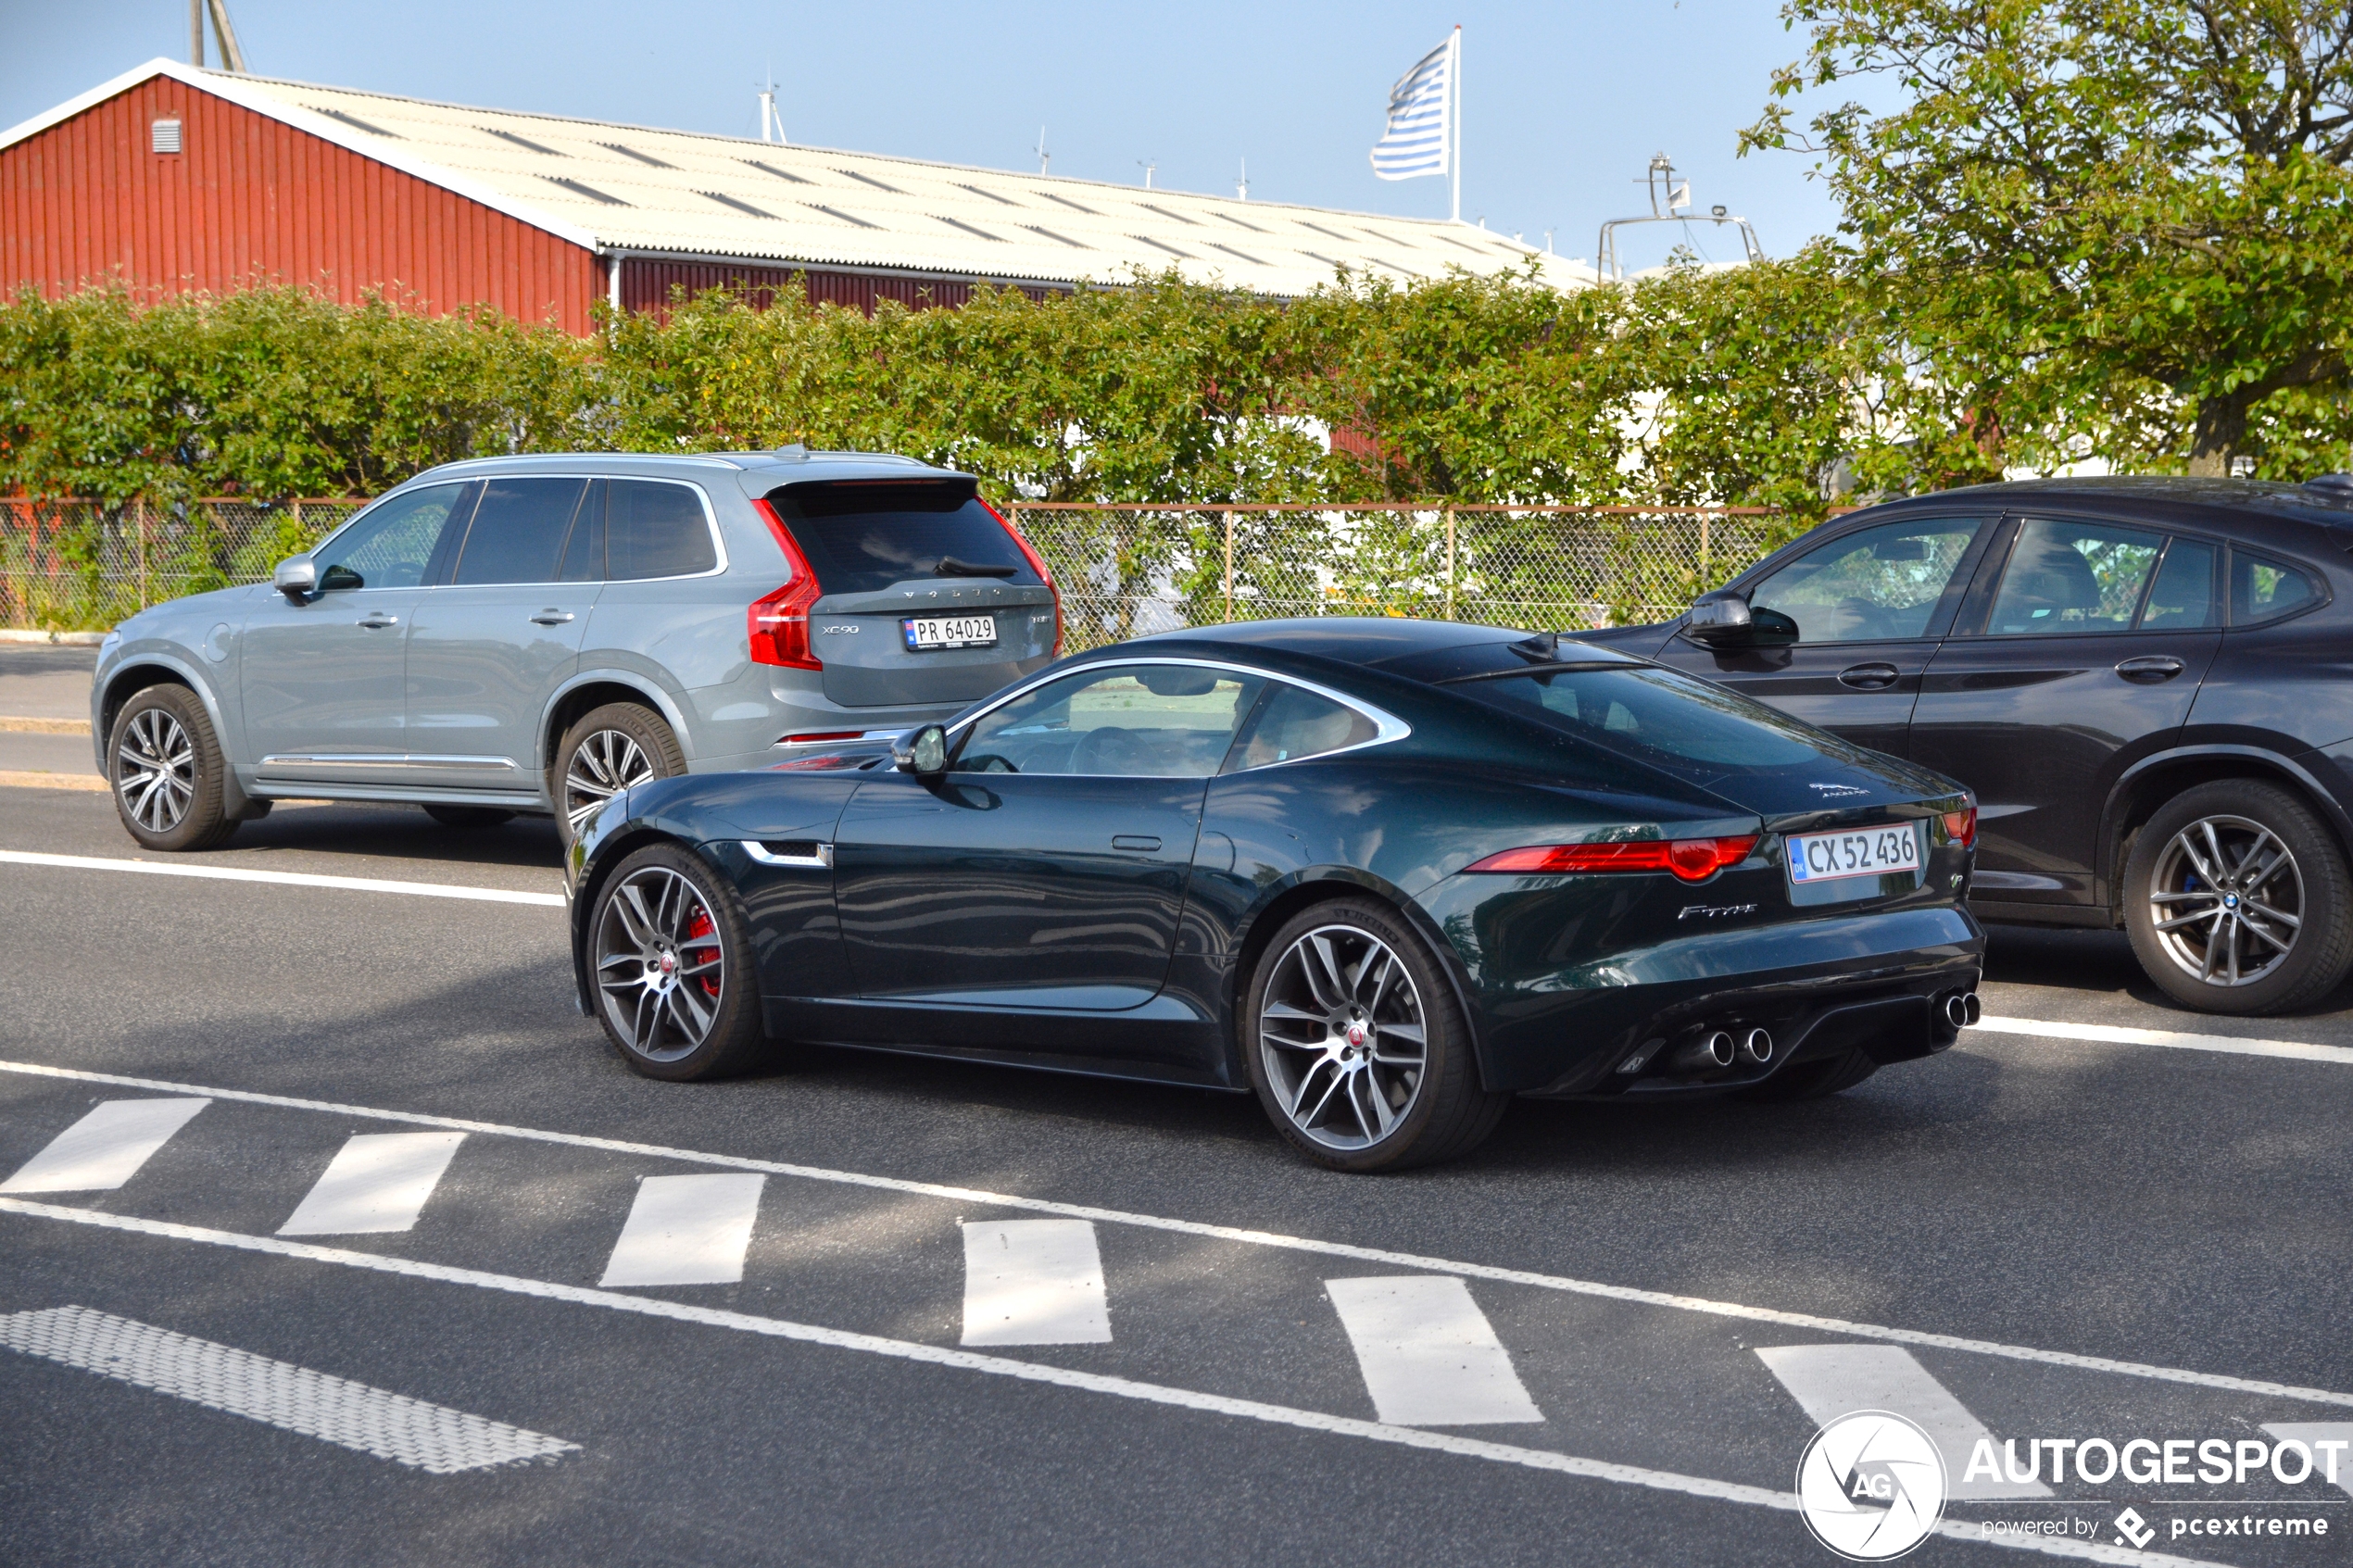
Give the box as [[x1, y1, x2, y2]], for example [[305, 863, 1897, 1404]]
[[0, 498, 360, 633]]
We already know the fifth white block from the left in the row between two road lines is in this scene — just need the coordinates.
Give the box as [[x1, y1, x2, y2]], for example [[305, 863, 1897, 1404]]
[[1325, 1274, 1543, 1427]]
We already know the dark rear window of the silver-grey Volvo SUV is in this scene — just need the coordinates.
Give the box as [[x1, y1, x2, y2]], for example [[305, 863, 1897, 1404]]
[[767, 480, 1038, 593]]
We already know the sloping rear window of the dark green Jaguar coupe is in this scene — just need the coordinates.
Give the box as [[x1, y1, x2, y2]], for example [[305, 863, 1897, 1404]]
[[1447, 668, 1849, 778]]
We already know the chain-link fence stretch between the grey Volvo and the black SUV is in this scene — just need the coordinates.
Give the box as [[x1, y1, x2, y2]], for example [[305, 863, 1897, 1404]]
[[1007, 501, 1783, 651]]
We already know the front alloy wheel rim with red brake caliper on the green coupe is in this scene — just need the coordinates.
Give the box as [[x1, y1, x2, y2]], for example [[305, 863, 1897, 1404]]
[[596, 865, 727, 1062]]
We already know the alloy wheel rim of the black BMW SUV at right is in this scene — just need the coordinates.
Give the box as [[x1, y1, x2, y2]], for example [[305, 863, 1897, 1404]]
[[2148, 816, 2304, 985]]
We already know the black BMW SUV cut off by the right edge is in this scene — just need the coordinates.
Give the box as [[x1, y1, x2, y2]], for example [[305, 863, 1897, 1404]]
[[1591, 475, 2353, 1013]]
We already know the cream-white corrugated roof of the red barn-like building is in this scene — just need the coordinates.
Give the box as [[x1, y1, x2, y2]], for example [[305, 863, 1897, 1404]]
[[0, 61, 1593, 296]]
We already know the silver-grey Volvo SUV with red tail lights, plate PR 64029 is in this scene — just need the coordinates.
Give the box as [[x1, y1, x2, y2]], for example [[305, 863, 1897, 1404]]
[[90, 446, 1062, 848]]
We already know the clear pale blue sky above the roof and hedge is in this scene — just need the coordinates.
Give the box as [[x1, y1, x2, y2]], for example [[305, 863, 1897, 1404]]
[[0, 0, 1835, 266]]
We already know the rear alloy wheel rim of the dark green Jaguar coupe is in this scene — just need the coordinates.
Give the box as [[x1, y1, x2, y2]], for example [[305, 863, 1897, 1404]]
[[1259, 926, 1428, 1149]]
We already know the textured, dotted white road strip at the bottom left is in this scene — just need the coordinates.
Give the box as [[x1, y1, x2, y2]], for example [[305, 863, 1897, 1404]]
[[0, 1307, 579, 1476]]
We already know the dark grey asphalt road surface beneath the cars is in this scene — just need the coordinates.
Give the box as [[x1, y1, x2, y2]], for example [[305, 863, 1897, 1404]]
[[0, 780, 2353, 1568]]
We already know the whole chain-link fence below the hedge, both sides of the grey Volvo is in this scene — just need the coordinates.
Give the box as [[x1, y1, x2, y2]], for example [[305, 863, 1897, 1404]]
[[0, 498, 1783, 651]]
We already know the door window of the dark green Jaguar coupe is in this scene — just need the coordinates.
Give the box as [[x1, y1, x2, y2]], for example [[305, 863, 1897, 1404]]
[[949, 665, 1264, 778]]
